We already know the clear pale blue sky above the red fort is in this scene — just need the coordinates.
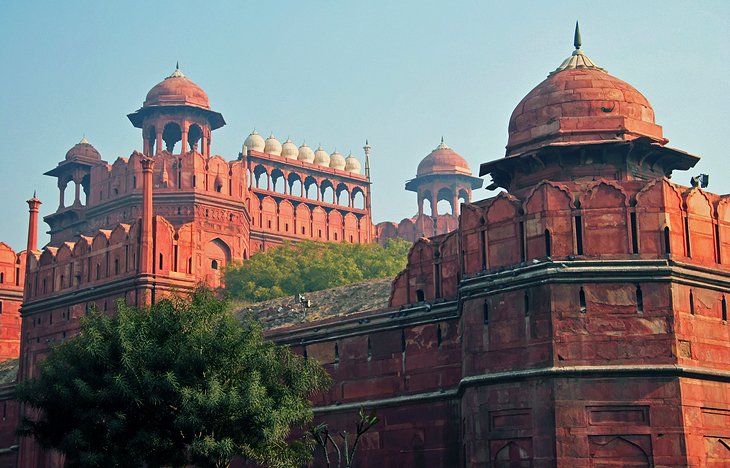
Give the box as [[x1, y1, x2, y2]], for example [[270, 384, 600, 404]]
[[0, 0, 730, 249]]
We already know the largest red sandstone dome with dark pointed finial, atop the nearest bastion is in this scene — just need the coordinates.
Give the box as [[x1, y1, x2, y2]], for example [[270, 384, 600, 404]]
[[507, 28, 667, 156]]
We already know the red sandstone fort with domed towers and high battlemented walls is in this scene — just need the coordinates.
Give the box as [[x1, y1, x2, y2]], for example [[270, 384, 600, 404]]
[[0, 27, 730, 468]]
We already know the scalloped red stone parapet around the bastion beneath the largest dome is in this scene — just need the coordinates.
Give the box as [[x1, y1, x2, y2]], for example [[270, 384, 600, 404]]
[[390, 178, 730, 304]]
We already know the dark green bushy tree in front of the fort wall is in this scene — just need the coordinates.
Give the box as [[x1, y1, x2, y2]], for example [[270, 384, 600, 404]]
[[17, 289, 330, 467]]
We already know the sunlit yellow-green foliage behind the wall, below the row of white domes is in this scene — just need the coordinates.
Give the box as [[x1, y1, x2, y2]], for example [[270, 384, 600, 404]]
[[225, 239, 412, 302]]
